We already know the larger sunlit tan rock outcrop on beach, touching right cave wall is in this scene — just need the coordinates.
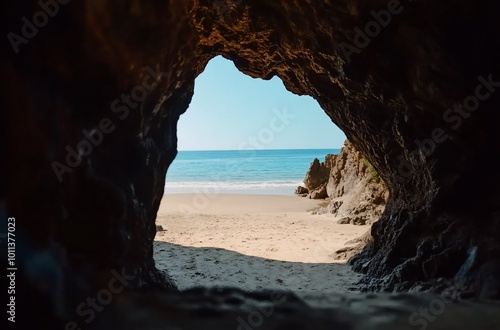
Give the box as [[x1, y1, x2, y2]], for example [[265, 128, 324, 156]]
[[316, 141, 389, 225]]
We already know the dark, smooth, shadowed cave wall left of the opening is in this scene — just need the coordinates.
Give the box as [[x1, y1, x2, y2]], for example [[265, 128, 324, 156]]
[[2, 1, 201, 294]]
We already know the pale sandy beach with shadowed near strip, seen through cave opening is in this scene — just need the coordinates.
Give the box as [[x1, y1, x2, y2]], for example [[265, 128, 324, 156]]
[[154, 194, 368, 297]]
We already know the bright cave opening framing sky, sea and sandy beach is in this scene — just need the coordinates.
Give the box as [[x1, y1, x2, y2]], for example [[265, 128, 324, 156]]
[[154, 57, 383, 295]]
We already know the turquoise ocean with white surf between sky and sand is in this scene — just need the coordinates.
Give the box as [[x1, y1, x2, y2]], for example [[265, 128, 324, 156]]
[[165, 149, 340, 195]]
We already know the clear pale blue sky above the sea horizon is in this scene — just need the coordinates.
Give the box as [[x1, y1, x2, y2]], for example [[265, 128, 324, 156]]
[[177, 56, 345, 150]]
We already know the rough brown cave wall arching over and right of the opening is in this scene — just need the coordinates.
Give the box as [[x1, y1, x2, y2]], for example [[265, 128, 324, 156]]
[[193, 0, 500, 296]]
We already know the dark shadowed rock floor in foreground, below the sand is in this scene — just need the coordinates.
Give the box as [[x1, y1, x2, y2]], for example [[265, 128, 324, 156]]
[[99, 288, 500, 330]]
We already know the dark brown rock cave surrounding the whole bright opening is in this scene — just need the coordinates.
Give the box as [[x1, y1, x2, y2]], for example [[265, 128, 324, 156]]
[[0, 0, 500, 329]]
